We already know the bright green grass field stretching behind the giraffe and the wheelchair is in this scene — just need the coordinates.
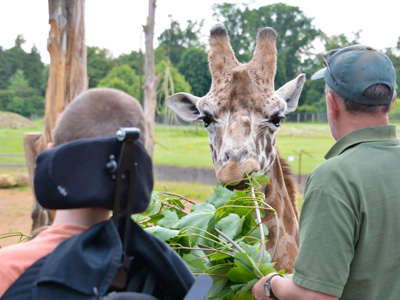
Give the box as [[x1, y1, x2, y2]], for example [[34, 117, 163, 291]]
[[0, 120, 399, 174]]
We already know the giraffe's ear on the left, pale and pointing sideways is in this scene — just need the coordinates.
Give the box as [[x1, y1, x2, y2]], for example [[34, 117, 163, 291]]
[[165, 93, 200, 122]]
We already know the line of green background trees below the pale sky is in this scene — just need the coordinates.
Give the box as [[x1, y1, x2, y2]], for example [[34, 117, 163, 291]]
[[0, 3, 400, 117]]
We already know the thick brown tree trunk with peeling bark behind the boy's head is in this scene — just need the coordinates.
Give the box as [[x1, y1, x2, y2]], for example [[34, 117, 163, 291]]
[[24, 0, 87, 230]]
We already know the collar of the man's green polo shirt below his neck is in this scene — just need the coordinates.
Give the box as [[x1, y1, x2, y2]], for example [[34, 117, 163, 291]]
[[325, 125, 397, 159]]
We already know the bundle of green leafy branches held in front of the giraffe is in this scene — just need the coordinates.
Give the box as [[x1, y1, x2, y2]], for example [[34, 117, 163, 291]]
[[134, 174, 275, 299]]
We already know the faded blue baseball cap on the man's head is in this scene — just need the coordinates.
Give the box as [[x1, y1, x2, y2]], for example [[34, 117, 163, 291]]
[[311, 45, 396, 105]]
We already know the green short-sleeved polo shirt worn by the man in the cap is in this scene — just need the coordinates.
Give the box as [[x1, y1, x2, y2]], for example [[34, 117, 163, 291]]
[[293, 125, 400, 300]]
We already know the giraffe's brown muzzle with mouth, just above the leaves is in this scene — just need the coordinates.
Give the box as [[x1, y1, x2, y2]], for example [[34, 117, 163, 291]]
[[215, 158, 260, 189]]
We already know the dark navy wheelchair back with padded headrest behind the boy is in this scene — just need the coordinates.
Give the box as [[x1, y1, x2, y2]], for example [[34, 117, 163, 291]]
[[1, 128, 212, 300]]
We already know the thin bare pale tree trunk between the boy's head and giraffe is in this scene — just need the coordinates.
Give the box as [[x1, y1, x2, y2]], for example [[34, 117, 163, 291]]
[[143, 0, 161, 157]]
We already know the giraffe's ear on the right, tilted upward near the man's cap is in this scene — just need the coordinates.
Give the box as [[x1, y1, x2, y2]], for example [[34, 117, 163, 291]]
[[275, 74, 306, 113]]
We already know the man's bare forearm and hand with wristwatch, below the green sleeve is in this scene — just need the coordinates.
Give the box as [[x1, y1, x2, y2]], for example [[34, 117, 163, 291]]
[[252, 274, 339, 300]]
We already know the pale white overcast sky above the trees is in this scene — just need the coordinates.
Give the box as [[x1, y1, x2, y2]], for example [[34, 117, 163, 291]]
[[0, 0, 400, 63]]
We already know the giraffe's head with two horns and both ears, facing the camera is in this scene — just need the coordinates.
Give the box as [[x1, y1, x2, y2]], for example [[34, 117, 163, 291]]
[[166, 25, 305, 185]]
